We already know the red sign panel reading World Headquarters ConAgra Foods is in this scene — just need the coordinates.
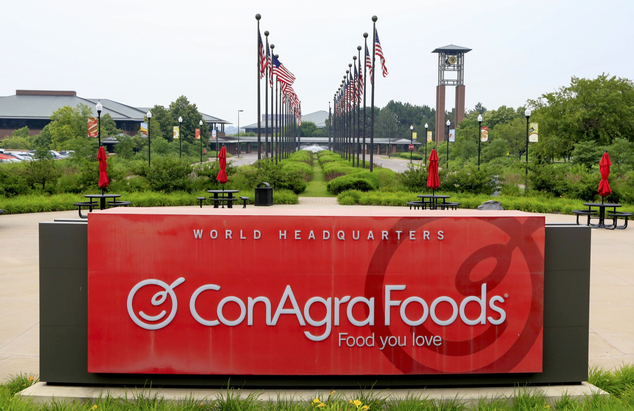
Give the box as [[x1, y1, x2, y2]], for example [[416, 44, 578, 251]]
[[88, 209, 545, 375]]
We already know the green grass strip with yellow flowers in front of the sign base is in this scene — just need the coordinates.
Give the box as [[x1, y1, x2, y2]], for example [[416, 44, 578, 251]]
[[0, 365, 634, 411]]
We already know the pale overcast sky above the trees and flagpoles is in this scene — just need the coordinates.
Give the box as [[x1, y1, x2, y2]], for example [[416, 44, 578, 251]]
[[0, 0, 634, 126]]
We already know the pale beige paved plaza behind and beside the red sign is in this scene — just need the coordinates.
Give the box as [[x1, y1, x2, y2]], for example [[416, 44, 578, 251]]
[[0, 206, 634, 381]]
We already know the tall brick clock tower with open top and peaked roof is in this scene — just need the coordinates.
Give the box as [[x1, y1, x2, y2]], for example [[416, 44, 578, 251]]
[[432, 44, 471, 142]]
